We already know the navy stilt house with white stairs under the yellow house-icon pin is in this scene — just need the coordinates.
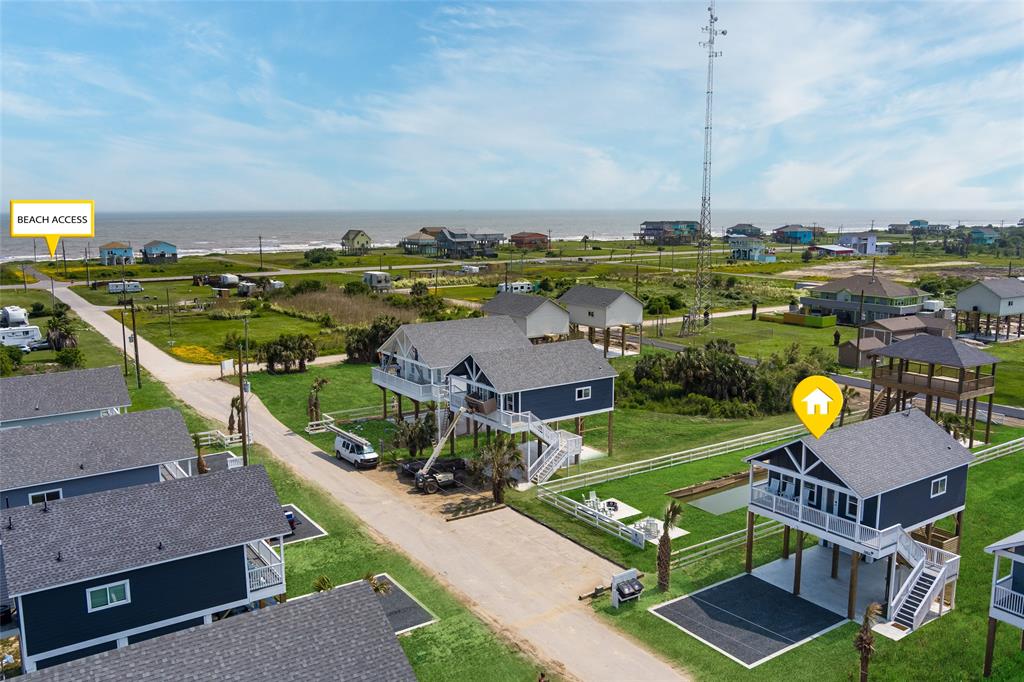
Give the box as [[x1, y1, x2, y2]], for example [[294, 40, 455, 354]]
[[745, 409, 973, 631]]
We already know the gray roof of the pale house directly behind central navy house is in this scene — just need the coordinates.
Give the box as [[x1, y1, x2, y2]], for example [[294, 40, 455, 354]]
[[384, 315, 532, 370]]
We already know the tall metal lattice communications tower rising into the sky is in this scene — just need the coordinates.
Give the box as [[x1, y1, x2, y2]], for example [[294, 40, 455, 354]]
[[679, 0, 726, 336]]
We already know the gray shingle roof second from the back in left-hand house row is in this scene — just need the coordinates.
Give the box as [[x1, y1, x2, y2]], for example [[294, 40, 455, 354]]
[[0, 408, 195, 491]]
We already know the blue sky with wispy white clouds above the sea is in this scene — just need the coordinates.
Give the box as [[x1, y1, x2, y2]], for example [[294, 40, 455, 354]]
[[0, 1, 1024, 210]]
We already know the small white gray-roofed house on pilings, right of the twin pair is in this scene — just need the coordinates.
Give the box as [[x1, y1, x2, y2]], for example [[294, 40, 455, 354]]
[[558, 285, 643, 357]]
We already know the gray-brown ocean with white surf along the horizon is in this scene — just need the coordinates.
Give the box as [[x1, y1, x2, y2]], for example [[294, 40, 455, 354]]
[[0, 209, 1020, 261]]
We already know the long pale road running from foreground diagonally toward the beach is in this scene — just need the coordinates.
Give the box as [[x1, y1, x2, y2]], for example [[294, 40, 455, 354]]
[[56, 287, 687, 682]]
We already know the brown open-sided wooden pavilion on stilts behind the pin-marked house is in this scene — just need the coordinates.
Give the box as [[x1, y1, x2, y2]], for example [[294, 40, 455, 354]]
[[868, 334, 999, 447]]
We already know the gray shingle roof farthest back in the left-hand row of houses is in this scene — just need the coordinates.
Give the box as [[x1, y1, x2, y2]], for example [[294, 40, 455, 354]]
[[0, 367, 131, 422]]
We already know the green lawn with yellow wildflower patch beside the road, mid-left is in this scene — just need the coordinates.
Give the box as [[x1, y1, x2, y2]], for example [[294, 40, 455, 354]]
[[109, 301, 343, 365]]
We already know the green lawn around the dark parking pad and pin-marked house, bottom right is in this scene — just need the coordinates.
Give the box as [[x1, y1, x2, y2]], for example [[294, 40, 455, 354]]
[[595, 446, 1024, 682]]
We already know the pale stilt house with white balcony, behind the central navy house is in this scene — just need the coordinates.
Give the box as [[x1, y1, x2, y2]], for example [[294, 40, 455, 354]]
[[372, 315, 532, 419]]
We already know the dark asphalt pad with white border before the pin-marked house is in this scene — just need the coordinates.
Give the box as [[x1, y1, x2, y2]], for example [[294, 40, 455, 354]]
[[650, 574, 846, 668]]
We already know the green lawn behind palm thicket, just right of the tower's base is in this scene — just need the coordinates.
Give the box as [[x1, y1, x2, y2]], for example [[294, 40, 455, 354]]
[[647, 315, 856, 357]]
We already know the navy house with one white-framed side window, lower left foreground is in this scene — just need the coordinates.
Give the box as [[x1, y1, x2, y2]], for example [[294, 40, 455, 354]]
[[0, 466, 289, 672]]
